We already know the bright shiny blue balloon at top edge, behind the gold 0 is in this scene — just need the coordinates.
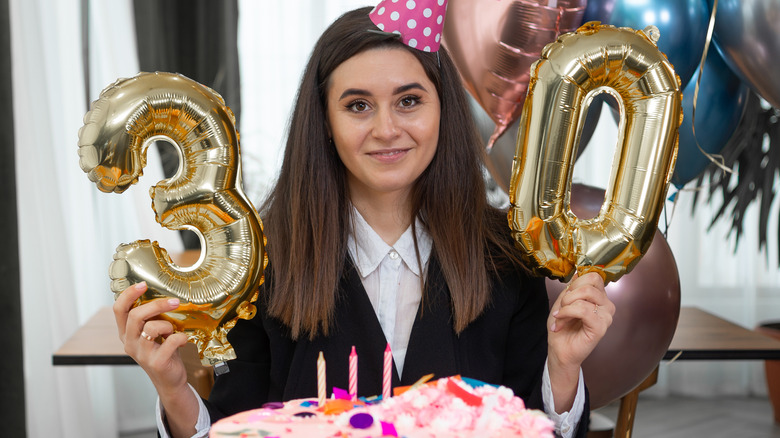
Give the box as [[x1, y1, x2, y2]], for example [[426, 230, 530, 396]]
[[583, 0, 710, 87]]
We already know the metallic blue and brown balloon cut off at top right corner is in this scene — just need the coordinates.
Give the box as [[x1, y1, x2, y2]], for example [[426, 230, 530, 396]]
[[709, 0, 780, 108]]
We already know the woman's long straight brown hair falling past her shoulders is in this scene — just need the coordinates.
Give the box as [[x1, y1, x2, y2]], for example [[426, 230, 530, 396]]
[[261, 8, 519, 339]]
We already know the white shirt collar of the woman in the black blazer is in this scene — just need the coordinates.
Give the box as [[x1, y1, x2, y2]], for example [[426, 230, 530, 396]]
[[347, 206, 432, 278]]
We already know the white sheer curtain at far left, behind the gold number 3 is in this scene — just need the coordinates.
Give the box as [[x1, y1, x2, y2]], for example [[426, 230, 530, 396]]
[[10, 0, 181, 437]]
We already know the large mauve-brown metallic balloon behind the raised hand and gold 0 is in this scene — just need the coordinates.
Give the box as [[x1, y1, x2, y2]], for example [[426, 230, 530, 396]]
[[547, 184, 680, 409]]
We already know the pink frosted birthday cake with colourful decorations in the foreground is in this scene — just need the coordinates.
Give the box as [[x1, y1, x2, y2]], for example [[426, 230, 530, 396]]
[[209, 377, 553, 438]]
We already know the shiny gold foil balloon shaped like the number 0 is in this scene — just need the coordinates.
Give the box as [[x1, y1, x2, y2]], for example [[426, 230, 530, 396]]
[[509, 22, 682, 282]]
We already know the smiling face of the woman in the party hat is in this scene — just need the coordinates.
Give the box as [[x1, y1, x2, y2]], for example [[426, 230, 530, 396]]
[[327, 48, 441, 201]]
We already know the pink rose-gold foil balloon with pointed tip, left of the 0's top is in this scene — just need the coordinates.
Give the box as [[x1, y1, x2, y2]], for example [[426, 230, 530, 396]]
[[444, 0, 587, 148]]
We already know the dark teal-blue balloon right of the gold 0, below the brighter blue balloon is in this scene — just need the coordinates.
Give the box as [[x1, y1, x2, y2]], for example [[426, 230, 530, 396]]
[[672, 47, 749, 188]]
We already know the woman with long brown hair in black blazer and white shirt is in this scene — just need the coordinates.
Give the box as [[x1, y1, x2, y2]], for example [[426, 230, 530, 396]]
[[114, 8, 614, 436]]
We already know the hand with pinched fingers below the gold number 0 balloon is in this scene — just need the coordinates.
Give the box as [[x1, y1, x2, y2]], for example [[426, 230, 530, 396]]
[[547, 272, 615, 370]]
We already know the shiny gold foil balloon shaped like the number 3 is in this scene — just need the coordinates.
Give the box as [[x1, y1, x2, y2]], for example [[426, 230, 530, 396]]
[[79, 73, 267, 372]]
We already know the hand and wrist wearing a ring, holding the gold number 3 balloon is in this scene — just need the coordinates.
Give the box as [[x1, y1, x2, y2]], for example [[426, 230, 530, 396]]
[[114, 283, 199, 436]]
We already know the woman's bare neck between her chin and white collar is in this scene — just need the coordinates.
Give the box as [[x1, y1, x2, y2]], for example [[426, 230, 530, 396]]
[[350, 188, 411, 245]]
